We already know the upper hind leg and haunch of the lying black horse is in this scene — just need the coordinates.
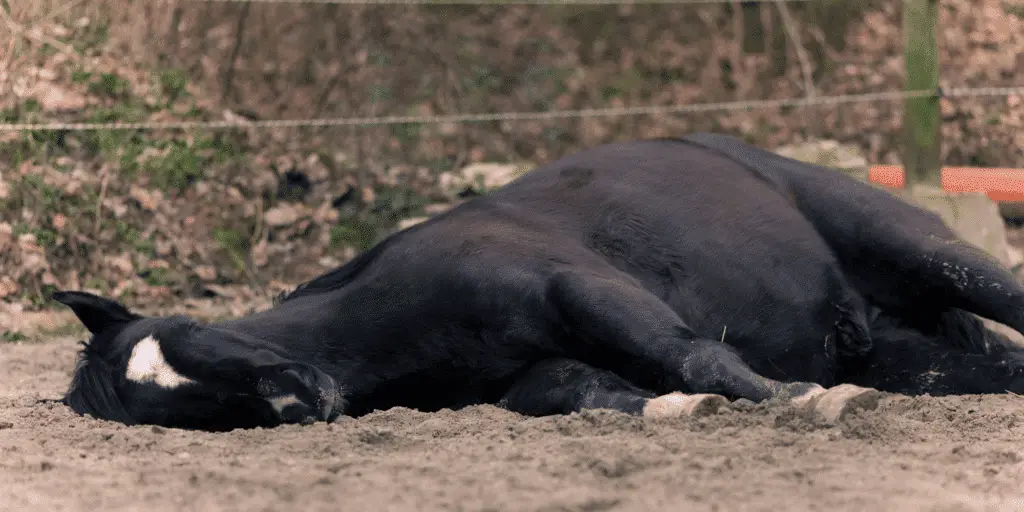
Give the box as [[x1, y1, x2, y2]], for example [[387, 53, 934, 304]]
[[671, 134, 1024, 334]]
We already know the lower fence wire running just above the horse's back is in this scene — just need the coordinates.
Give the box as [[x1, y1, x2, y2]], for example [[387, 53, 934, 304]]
[[0, 85, 1024, 131]]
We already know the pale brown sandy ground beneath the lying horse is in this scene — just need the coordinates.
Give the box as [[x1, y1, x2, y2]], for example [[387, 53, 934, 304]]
[[0, 338, 1024, 512]]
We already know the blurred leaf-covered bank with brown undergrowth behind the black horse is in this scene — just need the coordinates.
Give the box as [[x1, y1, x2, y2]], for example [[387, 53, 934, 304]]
[[0, 0, 1024, 319]]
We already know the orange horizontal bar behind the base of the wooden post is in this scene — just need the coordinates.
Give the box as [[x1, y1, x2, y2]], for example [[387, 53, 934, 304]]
[[868, 165, 1024, 203]]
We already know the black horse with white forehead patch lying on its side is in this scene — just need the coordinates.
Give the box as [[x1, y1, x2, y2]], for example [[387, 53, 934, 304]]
[[53, 134, 1024, 430]]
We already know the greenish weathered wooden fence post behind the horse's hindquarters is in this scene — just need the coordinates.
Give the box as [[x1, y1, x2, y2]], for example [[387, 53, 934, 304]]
[[903, 0, 942, 187]]
